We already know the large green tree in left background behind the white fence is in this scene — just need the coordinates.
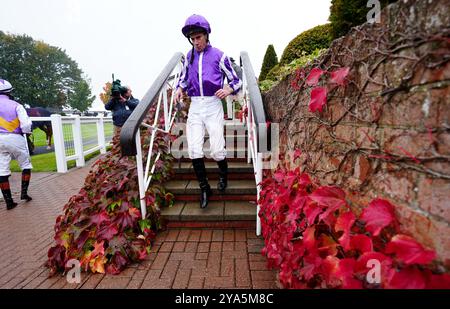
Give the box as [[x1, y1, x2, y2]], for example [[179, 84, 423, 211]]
[[0, 31, 87, 109]]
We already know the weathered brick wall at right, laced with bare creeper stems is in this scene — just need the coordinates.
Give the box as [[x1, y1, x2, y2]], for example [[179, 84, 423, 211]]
[[263, 0, 450, 266]]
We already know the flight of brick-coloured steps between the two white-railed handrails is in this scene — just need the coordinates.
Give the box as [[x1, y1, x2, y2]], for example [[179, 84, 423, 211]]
[[161, 120, 256, 228]]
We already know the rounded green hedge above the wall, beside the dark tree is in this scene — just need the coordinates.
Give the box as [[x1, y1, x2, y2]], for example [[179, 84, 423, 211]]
[[280, 24, 332, 65]]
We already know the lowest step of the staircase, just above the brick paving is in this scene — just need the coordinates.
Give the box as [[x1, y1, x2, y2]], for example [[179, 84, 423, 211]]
[[161, 201, 256, 222]]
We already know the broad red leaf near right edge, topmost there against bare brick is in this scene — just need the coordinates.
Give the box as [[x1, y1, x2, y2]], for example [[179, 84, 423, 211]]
[[386, 235, 436, 265]]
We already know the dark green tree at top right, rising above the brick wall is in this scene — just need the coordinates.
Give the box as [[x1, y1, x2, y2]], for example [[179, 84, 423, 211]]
[[329, 0, 397, 39]]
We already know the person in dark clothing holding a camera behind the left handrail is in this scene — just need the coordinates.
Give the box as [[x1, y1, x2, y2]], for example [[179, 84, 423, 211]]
[[105, 80, 139, 135]]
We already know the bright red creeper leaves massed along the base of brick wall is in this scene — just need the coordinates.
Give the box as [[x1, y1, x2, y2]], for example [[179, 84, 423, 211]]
[[258, 151, 450, 289]]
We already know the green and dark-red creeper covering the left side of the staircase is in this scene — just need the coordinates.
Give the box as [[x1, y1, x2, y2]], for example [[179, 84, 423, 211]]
[[47, 108, 174, 274]]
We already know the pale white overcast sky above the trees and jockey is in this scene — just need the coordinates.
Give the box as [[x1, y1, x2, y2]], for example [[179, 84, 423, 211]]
[[0, 0, 331, 109]]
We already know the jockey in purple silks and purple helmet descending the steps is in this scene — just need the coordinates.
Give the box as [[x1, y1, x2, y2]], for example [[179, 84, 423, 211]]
[[175, 15, 242, 208]]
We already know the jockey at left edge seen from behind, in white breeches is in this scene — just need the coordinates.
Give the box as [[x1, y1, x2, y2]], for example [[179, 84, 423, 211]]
[[0, 79, 33, 210]]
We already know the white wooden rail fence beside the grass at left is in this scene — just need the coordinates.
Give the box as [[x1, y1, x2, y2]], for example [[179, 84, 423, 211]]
[[30, 114, 112, 173]]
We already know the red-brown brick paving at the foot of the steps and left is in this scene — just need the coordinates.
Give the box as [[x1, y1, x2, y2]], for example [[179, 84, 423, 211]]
[[0, 158, 277, 289]]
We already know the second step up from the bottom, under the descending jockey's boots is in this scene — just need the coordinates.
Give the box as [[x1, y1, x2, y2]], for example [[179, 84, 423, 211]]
[[164, 180, 256, 196]]
